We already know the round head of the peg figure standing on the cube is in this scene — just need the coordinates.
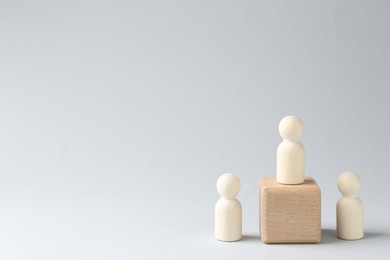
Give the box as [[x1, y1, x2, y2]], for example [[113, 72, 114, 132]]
[[279, 116, 303, 142]]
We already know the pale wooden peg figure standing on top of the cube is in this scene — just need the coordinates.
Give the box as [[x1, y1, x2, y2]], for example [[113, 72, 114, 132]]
[[276, 116, 305, 184]]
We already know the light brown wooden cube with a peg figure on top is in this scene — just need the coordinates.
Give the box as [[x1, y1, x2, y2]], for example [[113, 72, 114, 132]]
[[259, 177, 321, 243]]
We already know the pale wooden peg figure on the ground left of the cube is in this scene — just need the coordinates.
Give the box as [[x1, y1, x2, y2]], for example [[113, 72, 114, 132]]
[[215, 173, 242, 241]]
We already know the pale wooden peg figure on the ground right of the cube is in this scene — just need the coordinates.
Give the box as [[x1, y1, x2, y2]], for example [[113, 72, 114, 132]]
[[336, 171, 364, 240]]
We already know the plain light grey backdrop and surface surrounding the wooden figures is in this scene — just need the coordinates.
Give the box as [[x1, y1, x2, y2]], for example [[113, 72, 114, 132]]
[[0, 0, 390, 260]]
